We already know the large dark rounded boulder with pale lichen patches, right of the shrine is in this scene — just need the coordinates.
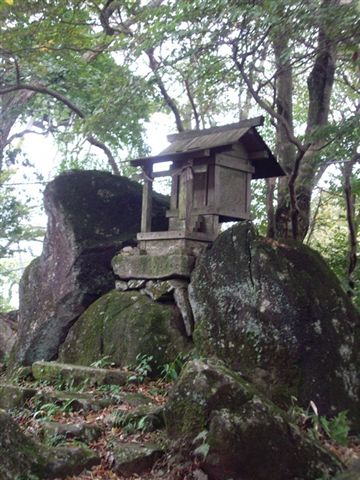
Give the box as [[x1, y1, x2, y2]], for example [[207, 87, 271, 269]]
[[189, 222, 360, 427]]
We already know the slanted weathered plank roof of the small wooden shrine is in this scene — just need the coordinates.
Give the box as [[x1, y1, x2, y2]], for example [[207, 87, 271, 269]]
[[130, 117, 285, 178]]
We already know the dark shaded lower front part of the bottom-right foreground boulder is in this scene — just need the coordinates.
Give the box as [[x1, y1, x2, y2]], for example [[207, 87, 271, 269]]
[[202, 406, 341, 480]]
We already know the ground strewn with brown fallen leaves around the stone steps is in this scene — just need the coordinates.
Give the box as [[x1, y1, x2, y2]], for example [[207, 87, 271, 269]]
[[0, 370, 360, 480]]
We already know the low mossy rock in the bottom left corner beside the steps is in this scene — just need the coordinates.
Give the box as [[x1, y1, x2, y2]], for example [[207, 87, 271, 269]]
[[0, 410, 100, 480]]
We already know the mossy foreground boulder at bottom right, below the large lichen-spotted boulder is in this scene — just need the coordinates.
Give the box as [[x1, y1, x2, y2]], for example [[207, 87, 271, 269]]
[[164, 359, 342, 480]]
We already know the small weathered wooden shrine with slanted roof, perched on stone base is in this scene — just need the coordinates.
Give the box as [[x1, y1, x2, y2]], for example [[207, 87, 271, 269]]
[[131, 117, 284, 254]]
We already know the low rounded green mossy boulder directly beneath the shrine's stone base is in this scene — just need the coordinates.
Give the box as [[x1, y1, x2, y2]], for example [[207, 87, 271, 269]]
[[60, 290, 189, 372]]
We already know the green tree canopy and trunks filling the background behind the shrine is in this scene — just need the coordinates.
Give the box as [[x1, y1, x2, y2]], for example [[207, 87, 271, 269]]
[[0, 0, 360, 308]]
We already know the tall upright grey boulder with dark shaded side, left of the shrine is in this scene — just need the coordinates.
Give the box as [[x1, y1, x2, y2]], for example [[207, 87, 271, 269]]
[[12, 171, 167, 365]]
